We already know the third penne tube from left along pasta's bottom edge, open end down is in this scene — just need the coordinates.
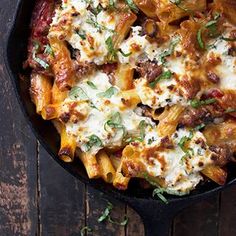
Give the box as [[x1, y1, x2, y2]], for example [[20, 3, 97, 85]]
[[97, 151, 116, 183]]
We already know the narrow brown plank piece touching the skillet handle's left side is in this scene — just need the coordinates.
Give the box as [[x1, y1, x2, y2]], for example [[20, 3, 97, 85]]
[[126, 207, 144, 236]]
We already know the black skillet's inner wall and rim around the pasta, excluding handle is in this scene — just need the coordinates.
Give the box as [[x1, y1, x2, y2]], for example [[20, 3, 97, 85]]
[[5, 0, 236, 205]]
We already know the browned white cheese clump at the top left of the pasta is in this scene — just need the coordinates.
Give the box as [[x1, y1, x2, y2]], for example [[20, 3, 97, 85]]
[[49, 0, 116, 65]]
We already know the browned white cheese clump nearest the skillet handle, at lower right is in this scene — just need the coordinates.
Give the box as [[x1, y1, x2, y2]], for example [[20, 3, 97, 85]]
[[134, 129, 212, 194]]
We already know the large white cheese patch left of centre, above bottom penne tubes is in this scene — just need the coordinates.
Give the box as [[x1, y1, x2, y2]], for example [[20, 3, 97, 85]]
[[65, 72, 153, 154]]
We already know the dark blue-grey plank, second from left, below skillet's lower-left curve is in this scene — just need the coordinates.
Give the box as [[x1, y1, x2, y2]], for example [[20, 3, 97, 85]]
[[39, 146, 85, 236]]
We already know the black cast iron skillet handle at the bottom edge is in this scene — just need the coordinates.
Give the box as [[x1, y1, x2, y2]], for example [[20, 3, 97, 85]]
[[129, 199, 192, 236]]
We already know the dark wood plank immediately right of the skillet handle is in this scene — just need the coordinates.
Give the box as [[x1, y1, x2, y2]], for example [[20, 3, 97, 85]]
[[173, 194, 220, 236]]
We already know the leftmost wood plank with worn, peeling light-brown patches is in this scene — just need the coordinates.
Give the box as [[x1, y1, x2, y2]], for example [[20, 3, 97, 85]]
[[0, 0, 37, 236]]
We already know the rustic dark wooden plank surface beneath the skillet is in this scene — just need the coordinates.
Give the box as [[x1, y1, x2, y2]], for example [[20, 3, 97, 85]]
[[0, 0, 236, 236]]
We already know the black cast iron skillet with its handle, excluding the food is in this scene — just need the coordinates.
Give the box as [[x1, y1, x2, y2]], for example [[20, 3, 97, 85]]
[[4, 0, 236, 236]]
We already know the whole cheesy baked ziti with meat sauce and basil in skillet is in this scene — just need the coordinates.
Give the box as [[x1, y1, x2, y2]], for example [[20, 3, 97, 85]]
[[24, 0, 236, 195]]
